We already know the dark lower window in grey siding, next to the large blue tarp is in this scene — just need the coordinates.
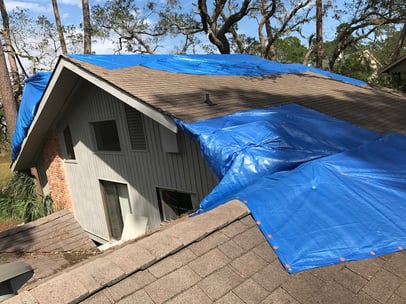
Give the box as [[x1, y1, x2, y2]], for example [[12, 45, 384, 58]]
[[158, 189, 193, 221]]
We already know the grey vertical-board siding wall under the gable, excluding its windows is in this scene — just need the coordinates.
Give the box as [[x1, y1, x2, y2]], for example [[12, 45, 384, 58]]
[[58, 83, 216, 241]]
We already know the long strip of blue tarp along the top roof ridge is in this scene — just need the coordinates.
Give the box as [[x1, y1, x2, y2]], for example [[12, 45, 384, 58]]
[[69, 54, 366, 85]]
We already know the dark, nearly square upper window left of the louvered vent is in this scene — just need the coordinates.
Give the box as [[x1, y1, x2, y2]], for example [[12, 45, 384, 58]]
[[91, 120, 121, 151]]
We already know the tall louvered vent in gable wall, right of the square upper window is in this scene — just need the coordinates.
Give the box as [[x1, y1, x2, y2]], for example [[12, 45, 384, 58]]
[[125, 104, 147, 150]]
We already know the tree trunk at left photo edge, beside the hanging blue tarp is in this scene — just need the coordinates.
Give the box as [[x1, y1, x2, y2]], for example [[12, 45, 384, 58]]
[[0, 40, 17, 138]]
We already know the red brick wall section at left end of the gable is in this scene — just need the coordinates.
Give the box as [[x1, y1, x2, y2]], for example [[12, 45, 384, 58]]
[[43, 129, 72, 210]]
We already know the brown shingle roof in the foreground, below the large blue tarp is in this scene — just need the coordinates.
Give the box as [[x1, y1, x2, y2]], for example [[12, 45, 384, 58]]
[[5, 201, 406, 304]]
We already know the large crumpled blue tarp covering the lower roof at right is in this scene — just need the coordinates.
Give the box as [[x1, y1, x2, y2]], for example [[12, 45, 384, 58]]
[[178, 105, 406, 273]]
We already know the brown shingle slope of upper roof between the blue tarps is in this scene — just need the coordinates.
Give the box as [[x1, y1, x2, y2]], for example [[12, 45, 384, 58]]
[[66, 58, 406, 134]]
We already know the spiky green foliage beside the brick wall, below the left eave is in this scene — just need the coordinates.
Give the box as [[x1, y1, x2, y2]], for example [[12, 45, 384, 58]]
[[0, 172, 53, 222]]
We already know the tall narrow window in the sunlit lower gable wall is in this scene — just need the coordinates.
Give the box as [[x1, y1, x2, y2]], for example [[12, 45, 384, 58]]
[[100, 180, 131, 240]]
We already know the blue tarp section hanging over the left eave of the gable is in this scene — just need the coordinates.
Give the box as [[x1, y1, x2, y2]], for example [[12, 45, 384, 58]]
[[11, 72, 51, 161]]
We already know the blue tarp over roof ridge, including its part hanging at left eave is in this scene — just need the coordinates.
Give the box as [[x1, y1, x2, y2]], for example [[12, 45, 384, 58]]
[[12, 54, 366, 161]]
